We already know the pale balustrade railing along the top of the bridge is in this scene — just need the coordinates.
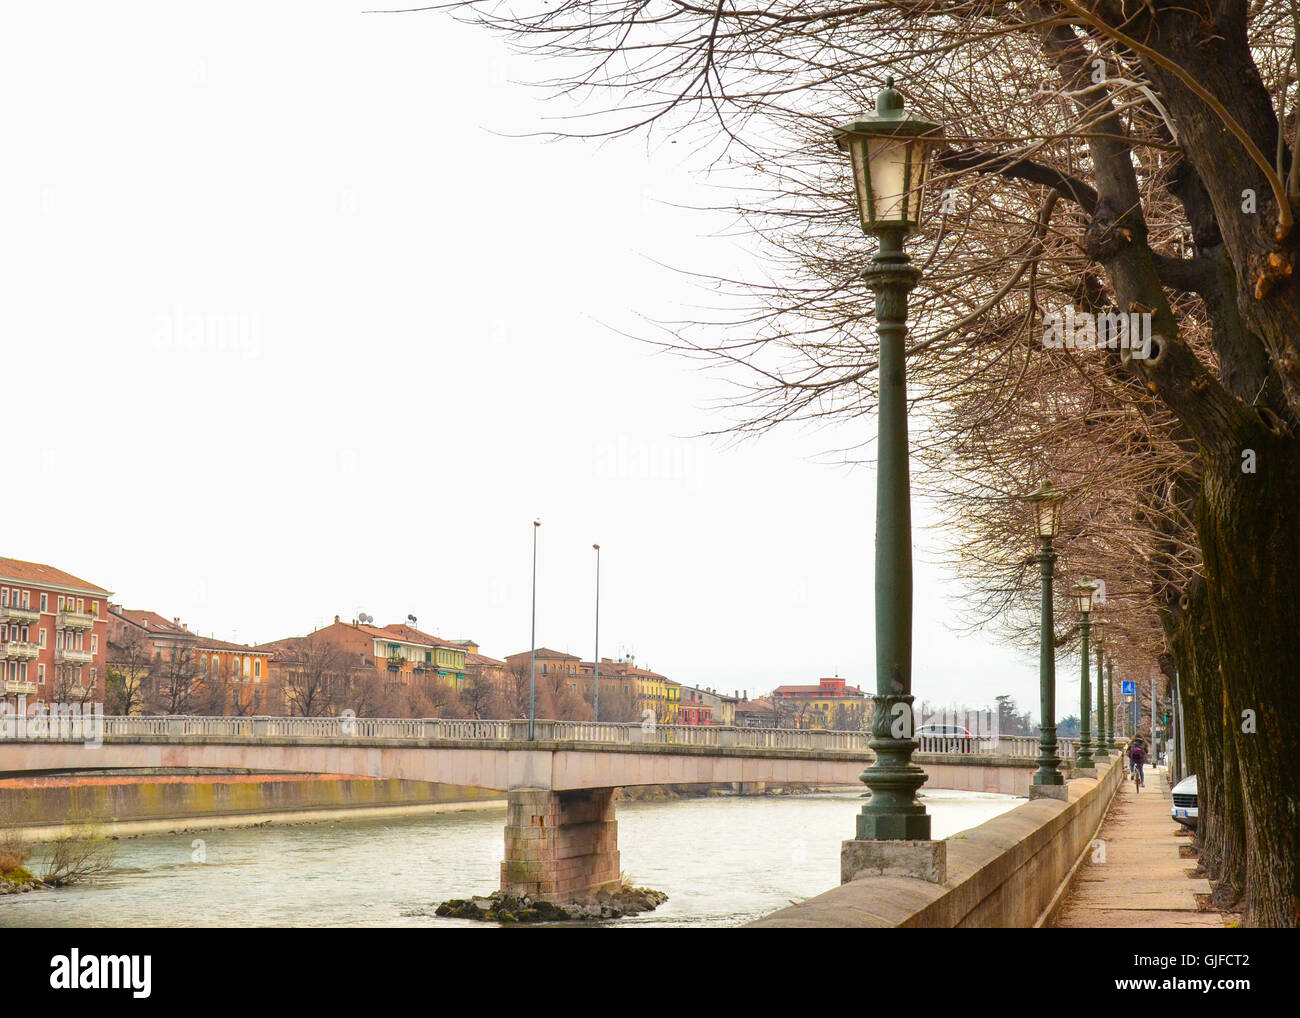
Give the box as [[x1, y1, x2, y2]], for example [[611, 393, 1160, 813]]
[[10, 715, 1075, 761]]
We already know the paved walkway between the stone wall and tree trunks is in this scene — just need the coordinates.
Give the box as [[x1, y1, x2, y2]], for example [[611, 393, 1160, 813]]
[[1050, 767, 1223, 928]]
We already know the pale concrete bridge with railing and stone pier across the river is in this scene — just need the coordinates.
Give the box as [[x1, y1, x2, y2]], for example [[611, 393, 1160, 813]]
[[0, 715, 1073, 897]]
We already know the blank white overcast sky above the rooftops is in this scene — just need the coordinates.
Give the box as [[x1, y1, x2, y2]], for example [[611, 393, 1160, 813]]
[[0, 0, 1078, 715]]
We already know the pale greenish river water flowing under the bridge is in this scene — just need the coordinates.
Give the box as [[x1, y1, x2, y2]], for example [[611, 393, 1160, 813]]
[[0, 789, 1023, 927]]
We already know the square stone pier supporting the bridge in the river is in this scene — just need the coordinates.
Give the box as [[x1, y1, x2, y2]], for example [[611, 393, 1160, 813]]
[[501, 788, 621, 900]]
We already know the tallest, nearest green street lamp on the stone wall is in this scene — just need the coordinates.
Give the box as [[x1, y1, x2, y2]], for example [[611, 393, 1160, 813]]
[[835, 78, 943, 841]]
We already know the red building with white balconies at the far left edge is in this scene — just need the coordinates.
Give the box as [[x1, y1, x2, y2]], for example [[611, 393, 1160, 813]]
[[0, 558, 112, 703]]
